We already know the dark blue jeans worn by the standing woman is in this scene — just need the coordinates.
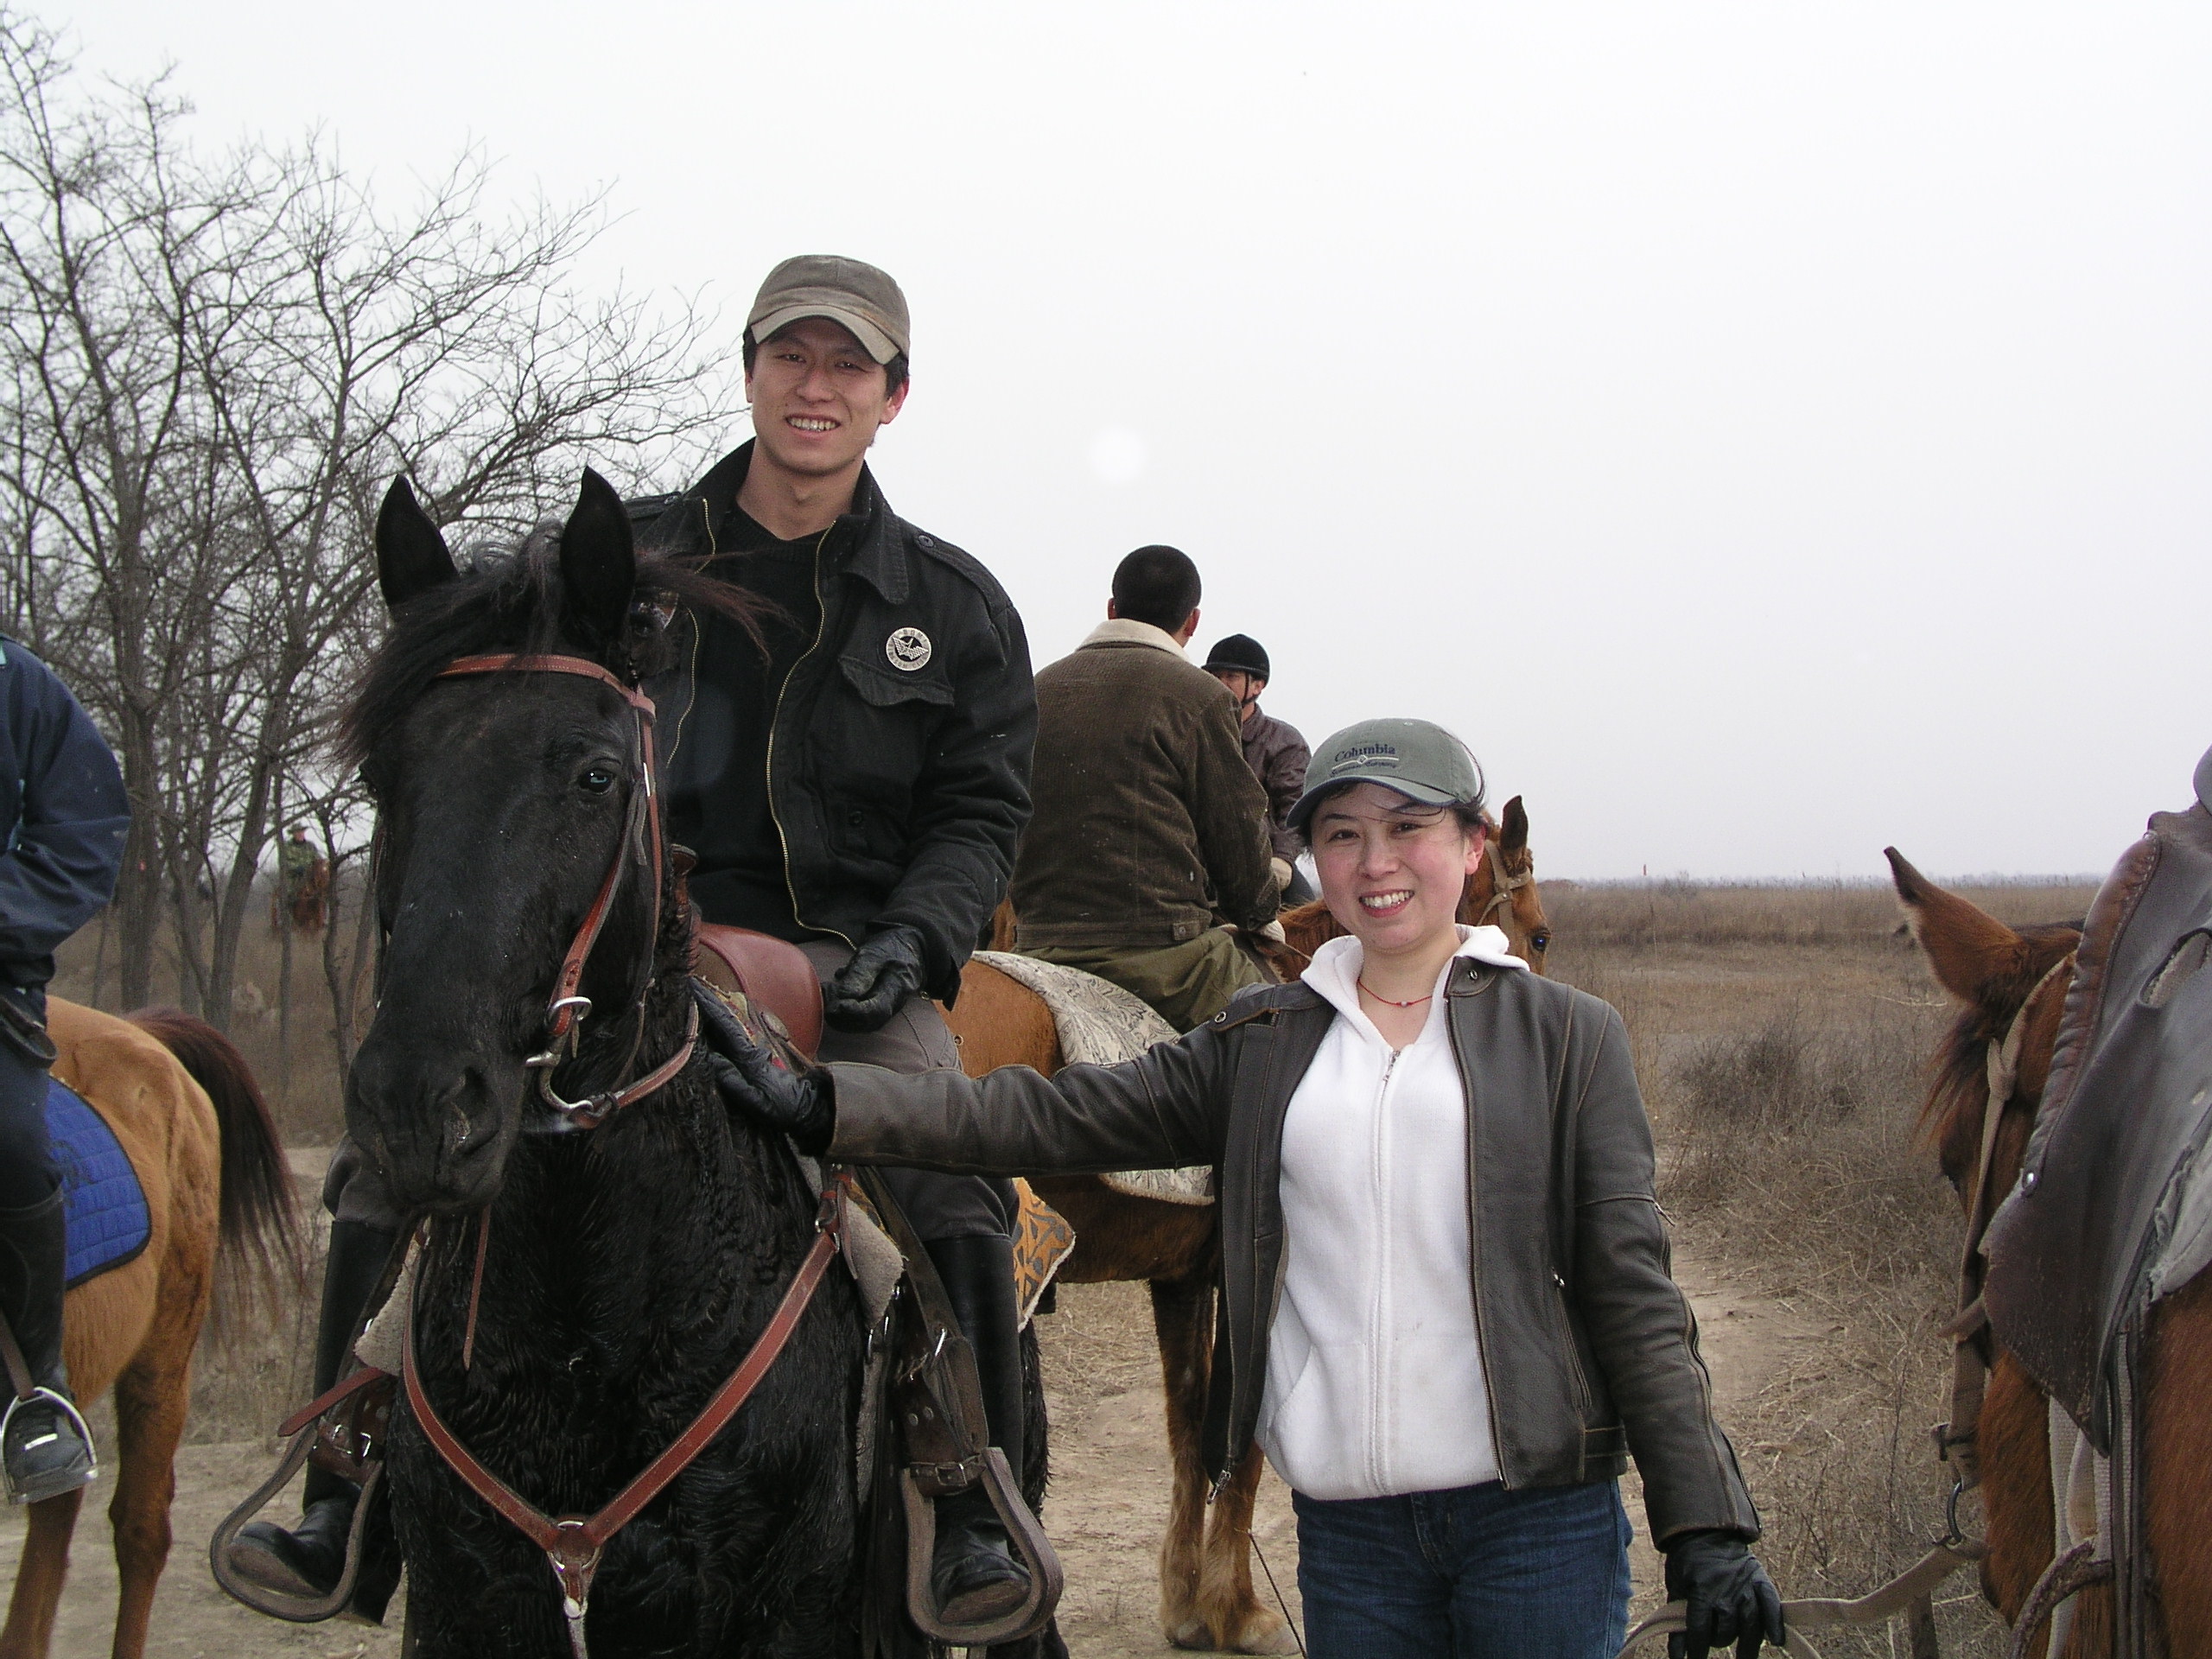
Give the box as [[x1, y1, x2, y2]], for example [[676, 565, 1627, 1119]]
[[1292, 1480, 1628, 1659]]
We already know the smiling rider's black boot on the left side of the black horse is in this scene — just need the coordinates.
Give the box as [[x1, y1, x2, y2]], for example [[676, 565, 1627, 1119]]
[[230, 1221, 398, 1619]]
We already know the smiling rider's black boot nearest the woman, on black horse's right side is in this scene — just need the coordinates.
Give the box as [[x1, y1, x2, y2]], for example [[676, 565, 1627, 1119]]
[[929, 1234, 1028, 1626]]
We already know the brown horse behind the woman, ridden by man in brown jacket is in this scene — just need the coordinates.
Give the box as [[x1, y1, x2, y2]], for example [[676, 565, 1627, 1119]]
[[944, 797, 1551, 1652]]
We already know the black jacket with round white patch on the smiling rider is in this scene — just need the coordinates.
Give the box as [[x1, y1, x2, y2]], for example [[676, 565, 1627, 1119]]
[[632, 442, 1038, 1002]]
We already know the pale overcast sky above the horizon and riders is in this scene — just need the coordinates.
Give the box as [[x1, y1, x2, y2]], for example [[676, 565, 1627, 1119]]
[[69, 0, 2212, 876]]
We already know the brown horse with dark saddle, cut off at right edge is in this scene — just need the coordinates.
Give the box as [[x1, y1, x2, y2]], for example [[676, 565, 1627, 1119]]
[[1889, 849, 2212, 1659]]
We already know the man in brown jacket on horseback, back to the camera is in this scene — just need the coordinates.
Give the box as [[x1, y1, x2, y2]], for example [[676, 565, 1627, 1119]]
[[1013, 546, 1281, 1031]]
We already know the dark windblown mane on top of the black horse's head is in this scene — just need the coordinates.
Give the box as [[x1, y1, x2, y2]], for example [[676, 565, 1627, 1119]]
[[339, 518, 770, 766]]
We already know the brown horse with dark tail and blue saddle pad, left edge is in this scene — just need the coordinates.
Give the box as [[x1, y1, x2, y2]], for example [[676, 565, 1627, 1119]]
[[0, 1000, 301, 1659]]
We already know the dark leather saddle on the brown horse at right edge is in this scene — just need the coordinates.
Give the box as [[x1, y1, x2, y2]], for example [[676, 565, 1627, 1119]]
[[1982, 754, 2212, 1455]]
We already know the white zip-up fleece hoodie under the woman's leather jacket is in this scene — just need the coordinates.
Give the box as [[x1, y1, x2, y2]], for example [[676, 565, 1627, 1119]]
[[1259, 927, 1529, 1497]]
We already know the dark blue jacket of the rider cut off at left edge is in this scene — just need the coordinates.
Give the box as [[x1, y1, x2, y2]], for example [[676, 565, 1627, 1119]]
[[0, 637, 130, 987]]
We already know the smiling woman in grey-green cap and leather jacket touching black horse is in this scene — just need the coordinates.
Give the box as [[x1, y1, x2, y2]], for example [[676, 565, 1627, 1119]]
[[710, 719, 1785, 1659]]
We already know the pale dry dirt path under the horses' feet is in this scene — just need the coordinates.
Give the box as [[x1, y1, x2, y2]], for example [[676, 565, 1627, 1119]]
[[0, 1248, 1812, 1659]]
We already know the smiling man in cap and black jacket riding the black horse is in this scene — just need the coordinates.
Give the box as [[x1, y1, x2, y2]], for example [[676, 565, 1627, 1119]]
[[241, 257, 1035, 1626]]
